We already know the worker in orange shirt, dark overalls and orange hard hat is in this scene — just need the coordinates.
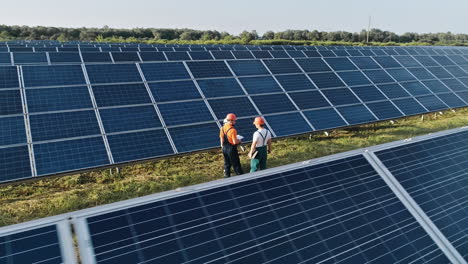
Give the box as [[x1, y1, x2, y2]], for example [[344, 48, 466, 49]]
[[219, 113, 244, 178]]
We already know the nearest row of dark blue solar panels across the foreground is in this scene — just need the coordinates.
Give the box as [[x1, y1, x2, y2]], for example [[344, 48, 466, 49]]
[[0, 127, 468, 264]]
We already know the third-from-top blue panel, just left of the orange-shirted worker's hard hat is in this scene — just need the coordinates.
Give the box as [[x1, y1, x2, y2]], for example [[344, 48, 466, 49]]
[[158, 101, 213, 126]]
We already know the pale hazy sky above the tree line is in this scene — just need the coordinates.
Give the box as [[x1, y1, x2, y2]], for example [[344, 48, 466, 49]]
[[0, 0, 468, 34]]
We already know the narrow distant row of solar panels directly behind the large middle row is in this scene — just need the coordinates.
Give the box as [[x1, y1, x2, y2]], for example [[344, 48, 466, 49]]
[[0, 50, 468, 66]]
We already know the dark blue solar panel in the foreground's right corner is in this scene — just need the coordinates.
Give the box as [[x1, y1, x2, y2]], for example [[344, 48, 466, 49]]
[[376, 131, 468, 260]]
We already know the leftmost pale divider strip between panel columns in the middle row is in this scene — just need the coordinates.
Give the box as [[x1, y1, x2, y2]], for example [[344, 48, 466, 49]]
[[17, 66, 37, 177]]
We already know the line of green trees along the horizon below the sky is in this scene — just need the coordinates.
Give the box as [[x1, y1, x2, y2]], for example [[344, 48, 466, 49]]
[[0, 25, 468, 45]]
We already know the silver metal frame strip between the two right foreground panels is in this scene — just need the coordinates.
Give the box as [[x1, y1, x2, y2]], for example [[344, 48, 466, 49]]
[[364, 150, 467, 263]]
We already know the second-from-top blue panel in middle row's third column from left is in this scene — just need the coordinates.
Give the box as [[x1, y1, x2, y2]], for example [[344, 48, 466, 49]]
[[93, 83, 151, 107]]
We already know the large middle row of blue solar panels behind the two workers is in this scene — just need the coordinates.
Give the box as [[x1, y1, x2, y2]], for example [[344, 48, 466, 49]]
[[0, 46, 468, 182]]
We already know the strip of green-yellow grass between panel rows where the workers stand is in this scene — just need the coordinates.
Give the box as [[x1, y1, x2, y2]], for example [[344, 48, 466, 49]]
[[0, 109, 468, 226]]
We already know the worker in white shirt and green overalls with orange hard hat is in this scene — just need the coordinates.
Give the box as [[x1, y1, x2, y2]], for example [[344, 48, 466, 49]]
[[248, 116, 271, 172]]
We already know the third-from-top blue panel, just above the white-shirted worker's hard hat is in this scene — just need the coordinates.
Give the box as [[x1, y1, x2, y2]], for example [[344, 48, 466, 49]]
[[252, 94, 297, 114]]
